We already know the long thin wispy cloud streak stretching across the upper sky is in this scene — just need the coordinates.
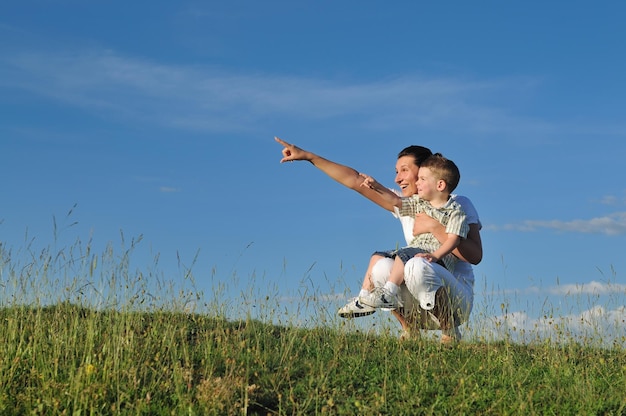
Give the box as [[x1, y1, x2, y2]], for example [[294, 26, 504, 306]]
[[0, 51, 552, 133]]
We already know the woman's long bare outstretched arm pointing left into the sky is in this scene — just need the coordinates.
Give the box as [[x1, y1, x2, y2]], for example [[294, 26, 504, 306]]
[[274, 137, 395, 212]]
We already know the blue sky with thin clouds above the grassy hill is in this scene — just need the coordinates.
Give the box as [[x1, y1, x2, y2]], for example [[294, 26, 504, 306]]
[[0, 0, 626, 342]]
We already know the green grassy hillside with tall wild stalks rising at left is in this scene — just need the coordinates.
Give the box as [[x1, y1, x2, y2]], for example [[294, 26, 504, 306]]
[[0, 231, 626, 415]]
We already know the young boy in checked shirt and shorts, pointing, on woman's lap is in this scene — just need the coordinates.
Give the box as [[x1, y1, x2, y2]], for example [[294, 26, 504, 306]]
[[359, 153, 469, 309]]
